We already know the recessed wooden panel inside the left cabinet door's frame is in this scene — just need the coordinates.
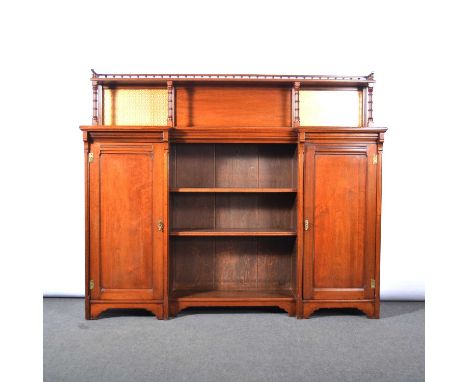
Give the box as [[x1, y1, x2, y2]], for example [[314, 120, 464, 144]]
[[99, 153, 153, 289]]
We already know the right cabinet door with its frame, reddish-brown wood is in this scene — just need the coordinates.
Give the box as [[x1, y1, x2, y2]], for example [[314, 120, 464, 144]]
[[303, 144, 377, 300]]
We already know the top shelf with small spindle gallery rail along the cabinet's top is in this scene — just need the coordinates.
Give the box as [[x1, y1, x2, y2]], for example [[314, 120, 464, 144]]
[[91, 69, 375, 86]]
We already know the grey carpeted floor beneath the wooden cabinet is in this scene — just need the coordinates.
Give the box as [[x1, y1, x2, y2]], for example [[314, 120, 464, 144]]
[[44, 298, 424, 382]]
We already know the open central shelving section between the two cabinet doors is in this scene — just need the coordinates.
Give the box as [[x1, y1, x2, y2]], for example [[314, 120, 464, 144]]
[[169, 143, 297, 310]]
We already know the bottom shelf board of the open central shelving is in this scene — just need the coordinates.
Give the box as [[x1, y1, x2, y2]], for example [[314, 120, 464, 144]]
[[170, 289, 294, 301]]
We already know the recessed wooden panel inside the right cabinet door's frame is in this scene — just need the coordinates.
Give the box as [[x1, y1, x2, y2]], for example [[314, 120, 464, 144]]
[[308, 154, 367, 288]]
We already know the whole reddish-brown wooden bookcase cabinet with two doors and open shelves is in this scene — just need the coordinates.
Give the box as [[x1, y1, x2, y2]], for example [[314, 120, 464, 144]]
[[81, 71, 386, 319]]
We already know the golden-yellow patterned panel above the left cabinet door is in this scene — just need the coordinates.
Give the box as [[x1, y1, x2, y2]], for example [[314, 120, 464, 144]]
[[104, 88, 168, 126]]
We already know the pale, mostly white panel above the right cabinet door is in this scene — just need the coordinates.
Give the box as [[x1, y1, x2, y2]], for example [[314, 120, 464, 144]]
[[299, 90, 362, 126]]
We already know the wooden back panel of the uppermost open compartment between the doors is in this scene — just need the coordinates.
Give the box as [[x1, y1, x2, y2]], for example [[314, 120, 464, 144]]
[[170, 143, 297, 188]]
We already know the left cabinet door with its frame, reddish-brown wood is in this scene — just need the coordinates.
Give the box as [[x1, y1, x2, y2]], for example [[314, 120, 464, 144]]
[[89, 143, 166, 300]]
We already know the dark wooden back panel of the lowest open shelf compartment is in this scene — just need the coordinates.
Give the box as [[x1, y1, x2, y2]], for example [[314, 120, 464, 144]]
[[170, 237, 296, 292]]
